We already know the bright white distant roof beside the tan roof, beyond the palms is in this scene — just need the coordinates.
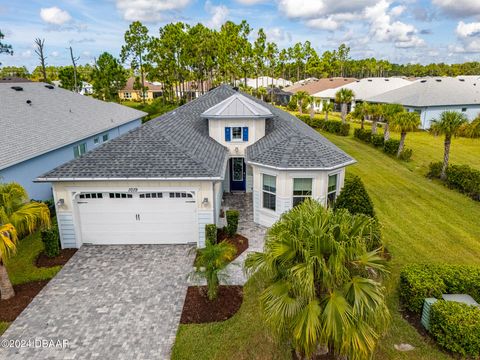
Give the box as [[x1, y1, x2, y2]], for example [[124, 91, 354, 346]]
[[313, 77, 412, 100]]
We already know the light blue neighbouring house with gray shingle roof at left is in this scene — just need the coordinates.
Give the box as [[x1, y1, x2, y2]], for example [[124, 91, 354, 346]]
[[0, 82, 146, 200]]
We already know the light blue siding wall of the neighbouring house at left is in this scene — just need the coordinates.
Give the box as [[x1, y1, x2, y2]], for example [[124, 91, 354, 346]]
[[0, 119, 142, 200]]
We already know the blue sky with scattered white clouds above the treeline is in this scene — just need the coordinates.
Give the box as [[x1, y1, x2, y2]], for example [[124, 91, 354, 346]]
[[0, 0, 480, 70]]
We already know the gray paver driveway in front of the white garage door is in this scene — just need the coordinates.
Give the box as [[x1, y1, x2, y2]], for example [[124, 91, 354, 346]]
[[0, 245, 194, 360]]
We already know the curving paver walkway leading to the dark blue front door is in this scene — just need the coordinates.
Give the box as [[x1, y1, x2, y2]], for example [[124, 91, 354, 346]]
[[218, 193, 267, 285]]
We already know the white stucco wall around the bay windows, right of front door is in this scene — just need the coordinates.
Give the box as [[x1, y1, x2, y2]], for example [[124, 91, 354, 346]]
[[252, 165, 345, 226]]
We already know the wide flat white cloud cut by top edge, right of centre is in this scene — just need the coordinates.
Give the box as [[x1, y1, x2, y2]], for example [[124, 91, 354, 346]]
[[278, 0, 377, 19]]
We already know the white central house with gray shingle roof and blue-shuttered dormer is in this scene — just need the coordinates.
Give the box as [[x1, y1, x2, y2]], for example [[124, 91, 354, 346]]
[[38, 85, 355, 247]]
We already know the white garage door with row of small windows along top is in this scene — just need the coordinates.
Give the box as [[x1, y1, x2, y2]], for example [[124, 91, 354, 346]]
[[77, 191, 198, 245]]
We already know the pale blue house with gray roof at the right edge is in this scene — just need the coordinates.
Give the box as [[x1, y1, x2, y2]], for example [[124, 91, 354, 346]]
[[366, 76, 480, 129]]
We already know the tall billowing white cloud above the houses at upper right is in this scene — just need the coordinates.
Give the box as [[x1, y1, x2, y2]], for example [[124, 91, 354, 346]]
[[365, 0, 425, 48]]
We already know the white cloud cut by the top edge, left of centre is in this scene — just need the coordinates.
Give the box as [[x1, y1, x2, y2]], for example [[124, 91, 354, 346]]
[[116, 0, 191, 22]]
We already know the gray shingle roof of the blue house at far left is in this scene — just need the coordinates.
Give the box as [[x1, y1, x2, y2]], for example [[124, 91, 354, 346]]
[[0, 82, 146, 169]]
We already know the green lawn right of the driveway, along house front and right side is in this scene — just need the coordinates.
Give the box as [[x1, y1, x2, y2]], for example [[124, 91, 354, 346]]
[[173, 123, 480, 360]]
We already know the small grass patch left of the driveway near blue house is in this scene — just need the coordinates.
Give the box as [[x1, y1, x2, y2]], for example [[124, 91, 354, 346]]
[[0, 231, 61, 335]]
